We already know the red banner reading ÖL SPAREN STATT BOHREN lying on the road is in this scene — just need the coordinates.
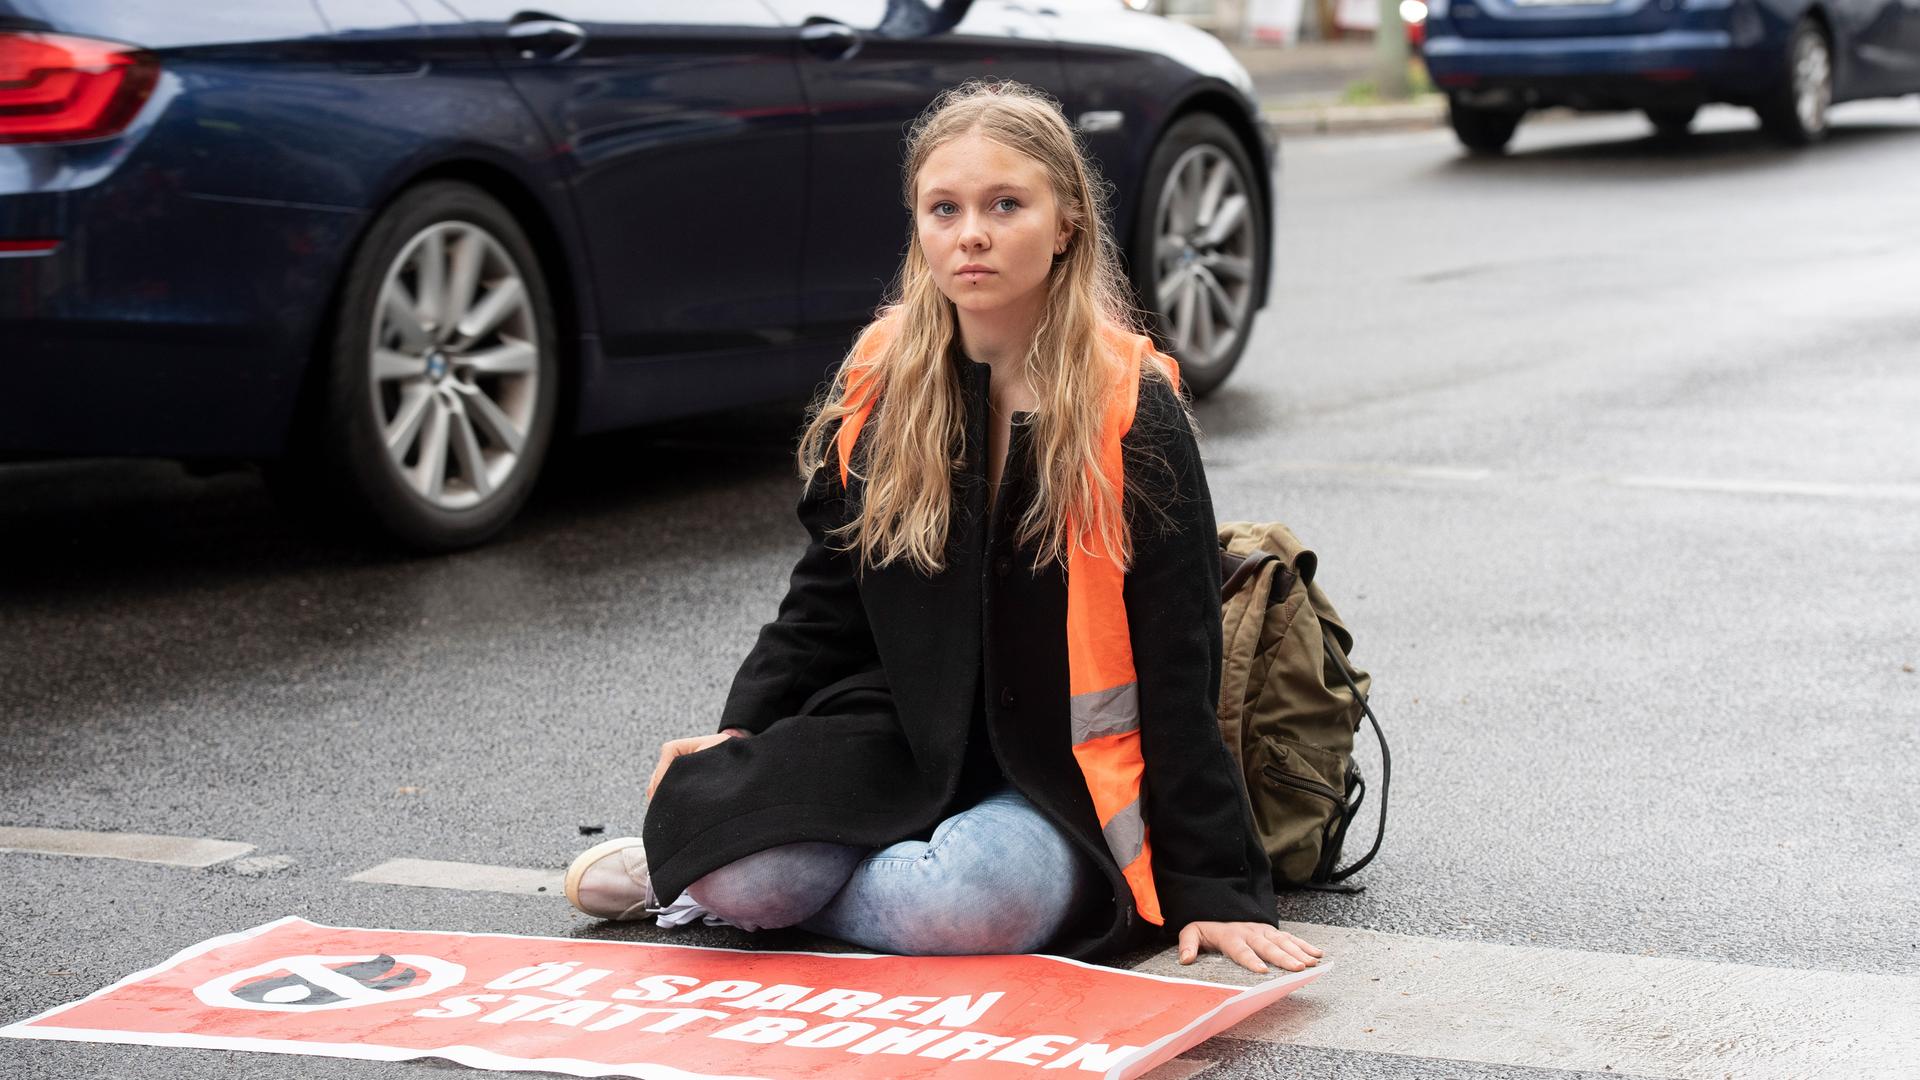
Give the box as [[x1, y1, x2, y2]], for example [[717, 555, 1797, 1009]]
[[0, 917, 1325, 1080]]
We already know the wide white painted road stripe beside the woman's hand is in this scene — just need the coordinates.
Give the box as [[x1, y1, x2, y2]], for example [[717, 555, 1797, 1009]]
[[1139, 922, 1920, 1080]]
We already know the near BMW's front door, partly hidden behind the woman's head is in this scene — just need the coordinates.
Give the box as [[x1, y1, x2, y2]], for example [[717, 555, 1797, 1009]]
[[770, 0, 1064, 336]]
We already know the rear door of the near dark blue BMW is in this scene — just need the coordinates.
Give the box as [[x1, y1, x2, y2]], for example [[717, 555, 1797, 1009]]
[[447, 0, 806, 359]]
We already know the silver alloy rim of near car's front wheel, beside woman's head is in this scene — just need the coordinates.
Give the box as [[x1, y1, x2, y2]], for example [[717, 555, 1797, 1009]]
[[1154, 144, 1258, 367]]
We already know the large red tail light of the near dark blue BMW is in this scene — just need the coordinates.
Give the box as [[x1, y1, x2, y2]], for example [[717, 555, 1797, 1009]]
[[0, 31, 159, 142]]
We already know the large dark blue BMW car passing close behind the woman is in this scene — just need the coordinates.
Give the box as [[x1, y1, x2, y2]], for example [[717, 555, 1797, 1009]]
[[0, 0, 1273, 548]]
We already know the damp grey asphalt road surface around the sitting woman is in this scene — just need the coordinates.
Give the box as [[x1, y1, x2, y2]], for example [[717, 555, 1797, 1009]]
[[0, 100, 1920, 1080]]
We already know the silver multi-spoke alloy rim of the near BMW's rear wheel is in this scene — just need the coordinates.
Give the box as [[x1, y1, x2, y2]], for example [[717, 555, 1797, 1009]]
[[369, 221, 541, 509]]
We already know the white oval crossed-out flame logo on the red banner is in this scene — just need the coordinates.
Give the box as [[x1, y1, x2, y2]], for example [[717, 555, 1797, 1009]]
[[194, 953, 467, 1013]]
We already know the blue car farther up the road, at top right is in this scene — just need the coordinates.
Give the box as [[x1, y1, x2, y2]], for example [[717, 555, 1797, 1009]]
[[1423, 0, 1920, 154]]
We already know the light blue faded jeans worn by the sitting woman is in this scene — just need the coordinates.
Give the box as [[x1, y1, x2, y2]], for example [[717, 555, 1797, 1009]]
[[687, 788, 1106, 957]]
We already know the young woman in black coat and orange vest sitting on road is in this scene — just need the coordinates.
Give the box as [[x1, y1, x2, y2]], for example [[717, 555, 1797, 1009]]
[[566, 83, 1321, 970]]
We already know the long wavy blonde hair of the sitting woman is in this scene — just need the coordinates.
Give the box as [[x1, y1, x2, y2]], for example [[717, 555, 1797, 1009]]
[[797, 81, 1192, 575]]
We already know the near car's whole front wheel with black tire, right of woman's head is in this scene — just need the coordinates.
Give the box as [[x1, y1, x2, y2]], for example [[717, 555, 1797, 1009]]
[[1127, 113, 1271, 400]]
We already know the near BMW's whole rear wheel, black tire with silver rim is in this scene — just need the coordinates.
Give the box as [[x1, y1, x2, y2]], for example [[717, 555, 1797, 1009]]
[[303, 181, 561, 552]]
